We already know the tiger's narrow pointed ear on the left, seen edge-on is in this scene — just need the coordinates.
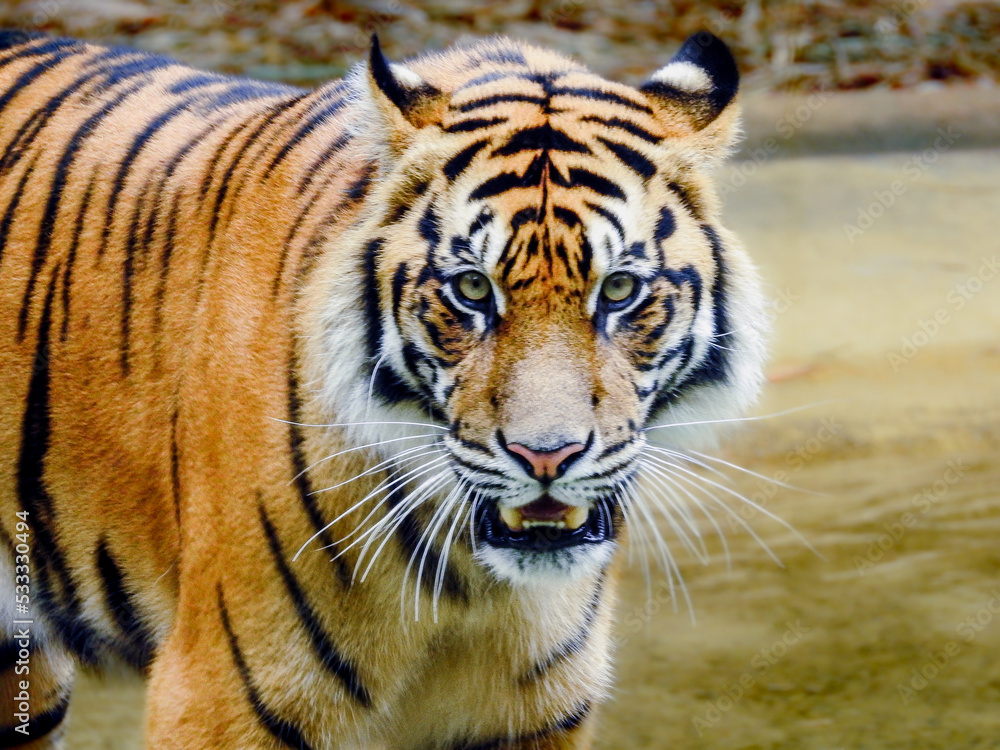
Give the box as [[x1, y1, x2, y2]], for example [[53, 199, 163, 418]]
[[368, 34, 448, 142]]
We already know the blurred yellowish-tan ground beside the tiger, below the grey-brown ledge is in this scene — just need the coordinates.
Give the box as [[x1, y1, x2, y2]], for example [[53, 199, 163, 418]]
[[62, 153, 1000, 750]]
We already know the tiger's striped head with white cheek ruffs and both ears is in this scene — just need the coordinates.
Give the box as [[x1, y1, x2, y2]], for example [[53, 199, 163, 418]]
[[308, 33, 766, 581]]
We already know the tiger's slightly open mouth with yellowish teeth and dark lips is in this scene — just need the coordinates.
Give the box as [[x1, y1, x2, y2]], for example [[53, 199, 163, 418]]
[[476, 495, 615, 552]]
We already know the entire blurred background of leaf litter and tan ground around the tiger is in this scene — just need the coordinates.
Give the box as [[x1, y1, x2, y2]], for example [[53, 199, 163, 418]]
[[0, 0, 1000, 750]]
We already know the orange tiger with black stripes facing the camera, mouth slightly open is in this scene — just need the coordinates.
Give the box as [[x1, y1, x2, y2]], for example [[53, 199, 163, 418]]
[[0, 26, 769, 750]]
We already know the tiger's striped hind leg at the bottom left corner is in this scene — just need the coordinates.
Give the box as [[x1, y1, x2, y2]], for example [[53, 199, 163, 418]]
[[0, 632, 76, 750]]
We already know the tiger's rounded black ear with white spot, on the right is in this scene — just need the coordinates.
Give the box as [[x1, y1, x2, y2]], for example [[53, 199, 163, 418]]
[[640, 31, 740, 157]]
